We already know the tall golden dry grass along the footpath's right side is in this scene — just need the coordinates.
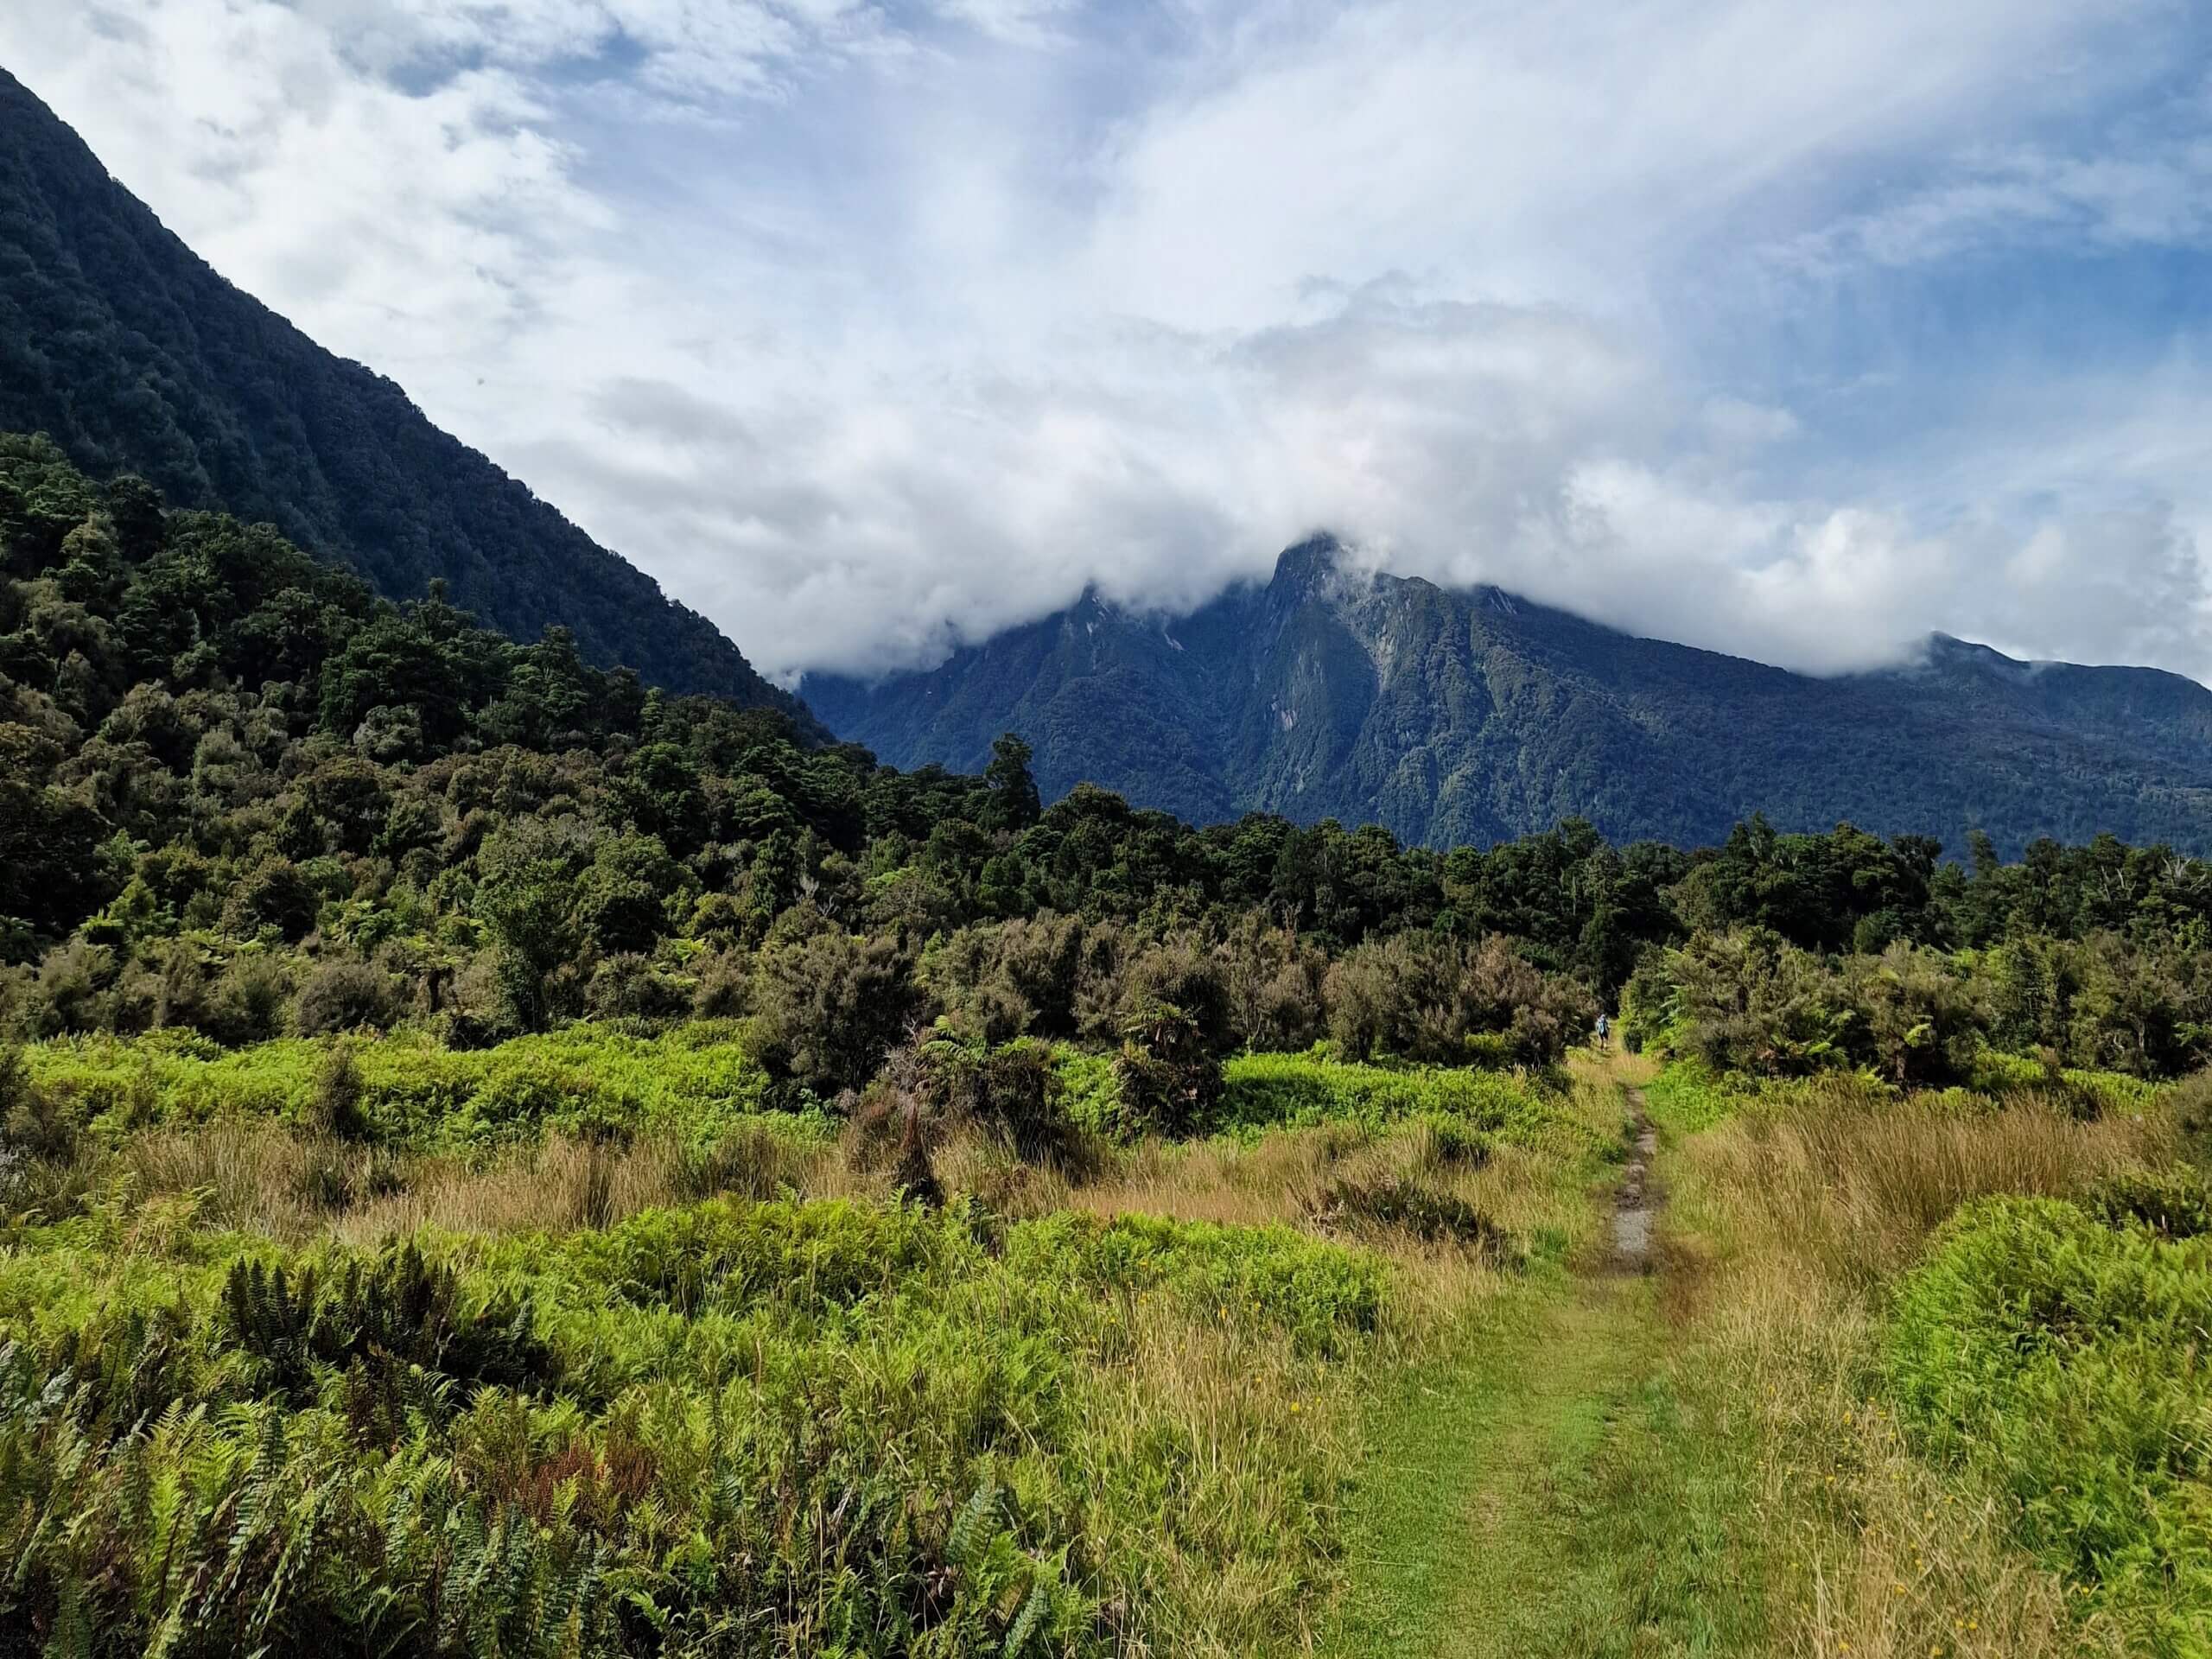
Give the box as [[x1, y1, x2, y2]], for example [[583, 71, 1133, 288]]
[[1668, 1079, 2170, 1659]]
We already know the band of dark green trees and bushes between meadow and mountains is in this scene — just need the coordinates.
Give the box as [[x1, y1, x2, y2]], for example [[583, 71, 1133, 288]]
[[0, 438, 2212, 1095]]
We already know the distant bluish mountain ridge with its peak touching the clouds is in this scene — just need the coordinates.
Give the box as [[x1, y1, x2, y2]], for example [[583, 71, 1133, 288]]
[[801, 537, 2212, 854]]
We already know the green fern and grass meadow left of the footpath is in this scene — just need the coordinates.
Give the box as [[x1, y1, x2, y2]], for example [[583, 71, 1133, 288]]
[[0, 1027, 1621, 1655]]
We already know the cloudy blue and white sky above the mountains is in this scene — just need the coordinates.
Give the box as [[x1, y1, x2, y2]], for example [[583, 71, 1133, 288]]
[[13, 0, 2212, 679]]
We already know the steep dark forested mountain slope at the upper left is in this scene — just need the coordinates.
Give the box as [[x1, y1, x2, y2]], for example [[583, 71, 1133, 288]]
[[0, 71, 821, 736]]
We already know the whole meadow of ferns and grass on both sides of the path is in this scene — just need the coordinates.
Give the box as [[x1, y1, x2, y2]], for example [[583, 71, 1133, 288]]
[[0, 1022, 2212, 1659]]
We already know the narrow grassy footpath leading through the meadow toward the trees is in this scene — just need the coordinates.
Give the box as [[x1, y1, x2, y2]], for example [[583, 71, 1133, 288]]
[[1320, 1089, 1761, 1659]]
